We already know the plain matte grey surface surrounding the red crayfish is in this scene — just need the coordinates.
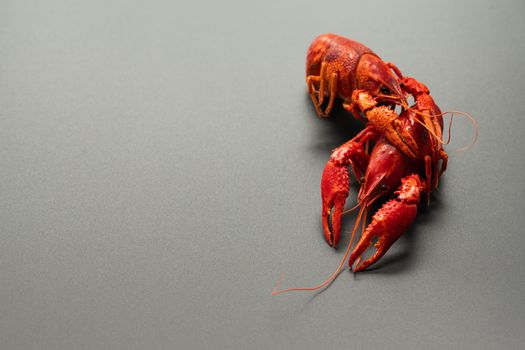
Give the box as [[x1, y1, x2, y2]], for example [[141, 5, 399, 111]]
[[0, 0, 525, 349]]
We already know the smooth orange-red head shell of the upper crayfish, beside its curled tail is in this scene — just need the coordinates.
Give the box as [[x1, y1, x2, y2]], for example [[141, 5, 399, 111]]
[[356, 54, 406, 105]]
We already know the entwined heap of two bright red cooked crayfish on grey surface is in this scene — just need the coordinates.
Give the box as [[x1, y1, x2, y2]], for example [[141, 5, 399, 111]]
[[272, 34, 472, 295]]
